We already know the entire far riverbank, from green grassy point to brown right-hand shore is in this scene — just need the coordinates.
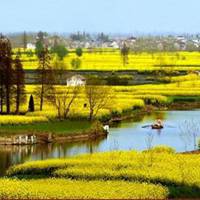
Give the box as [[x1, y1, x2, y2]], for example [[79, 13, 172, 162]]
[[0, 102, 200, 145]]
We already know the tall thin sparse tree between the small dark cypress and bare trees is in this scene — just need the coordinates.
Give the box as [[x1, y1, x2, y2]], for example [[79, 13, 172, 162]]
[[36, 47, 54, 111]]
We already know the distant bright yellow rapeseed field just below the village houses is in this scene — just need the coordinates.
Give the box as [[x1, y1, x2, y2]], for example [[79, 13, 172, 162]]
[[14, 49, 200, 71]]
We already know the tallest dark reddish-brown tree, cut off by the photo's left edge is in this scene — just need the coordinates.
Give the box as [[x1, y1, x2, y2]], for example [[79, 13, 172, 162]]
[[0, 35, 14, 114]]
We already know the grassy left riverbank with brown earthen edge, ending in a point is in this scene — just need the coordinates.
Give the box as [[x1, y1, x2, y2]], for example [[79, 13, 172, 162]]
[[0, 121, 108, 145]]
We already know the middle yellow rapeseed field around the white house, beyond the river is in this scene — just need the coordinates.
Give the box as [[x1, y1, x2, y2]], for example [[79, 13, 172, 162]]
[[0, 75, 200, 124]]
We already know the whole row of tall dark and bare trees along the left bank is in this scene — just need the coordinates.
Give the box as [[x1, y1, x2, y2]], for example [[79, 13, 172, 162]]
[[0, 35, 113, 120]]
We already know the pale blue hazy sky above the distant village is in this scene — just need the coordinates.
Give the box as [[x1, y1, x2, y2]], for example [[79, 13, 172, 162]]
[[0, 0, 200, 33]]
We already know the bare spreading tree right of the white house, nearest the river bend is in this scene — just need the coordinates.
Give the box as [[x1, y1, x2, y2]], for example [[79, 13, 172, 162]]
[[85, 82, 113, 121]]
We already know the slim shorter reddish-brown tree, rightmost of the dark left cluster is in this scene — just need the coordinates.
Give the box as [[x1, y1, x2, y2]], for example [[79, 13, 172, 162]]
[[14, 57, 26, 114]]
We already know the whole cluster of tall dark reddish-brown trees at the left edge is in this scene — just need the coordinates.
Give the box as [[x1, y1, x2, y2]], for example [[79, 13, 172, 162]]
[[0, 35, 25, 114]]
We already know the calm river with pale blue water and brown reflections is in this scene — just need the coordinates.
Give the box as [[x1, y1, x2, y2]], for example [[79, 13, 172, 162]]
[[0, 111, 200, 175]]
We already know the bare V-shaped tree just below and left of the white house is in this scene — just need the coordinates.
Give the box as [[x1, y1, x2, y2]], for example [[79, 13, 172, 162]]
[[52, 86, 80, 119]]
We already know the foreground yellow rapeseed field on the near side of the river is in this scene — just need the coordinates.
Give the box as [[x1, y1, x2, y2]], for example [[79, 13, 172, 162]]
[[3, 146, 200, 199]]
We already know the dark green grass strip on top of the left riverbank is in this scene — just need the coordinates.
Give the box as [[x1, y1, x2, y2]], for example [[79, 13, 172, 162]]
[[0, 120, 91, 135]]
